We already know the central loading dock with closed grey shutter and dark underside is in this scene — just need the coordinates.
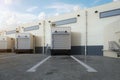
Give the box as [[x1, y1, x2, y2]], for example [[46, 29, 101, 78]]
[[51, 27, 71, 55]]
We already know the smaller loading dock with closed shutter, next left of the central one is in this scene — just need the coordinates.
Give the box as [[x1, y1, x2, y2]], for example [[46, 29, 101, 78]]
[[15, 33, 34, 53]]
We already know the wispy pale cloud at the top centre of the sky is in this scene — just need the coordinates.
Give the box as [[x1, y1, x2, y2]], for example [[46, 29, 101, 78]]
[[47, 3, 84, 13]]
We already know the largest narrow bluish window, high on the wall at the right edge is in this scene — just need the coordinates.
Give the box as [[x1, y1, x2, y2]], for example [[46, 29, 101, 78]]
[[100, 8, 120, 18]]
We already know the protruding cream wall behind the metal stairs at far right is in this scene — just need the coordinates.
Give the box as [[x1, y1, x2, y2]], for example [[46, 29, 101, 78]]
[[104, 19, 120, 58]]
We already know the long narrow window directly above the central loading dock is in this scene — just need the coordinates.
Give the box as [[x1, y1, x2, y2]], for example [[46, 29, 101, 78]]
[[53, 18, 77, 26]]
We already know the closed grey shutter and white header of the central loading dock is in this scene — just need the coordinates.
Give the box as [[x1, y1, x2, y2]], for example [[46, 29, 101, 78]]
[[51, 27, 71, 49]]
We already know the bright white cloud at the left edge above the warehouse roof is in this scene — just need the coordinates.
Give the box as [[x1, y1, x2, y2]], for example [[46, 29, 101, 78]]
[[0, 11, 38, 29]]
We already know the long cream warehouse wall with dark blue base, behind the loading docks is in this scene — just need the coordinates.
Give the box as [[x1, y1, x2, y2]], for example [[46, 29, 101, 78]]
[[1, 2, 120, 57]]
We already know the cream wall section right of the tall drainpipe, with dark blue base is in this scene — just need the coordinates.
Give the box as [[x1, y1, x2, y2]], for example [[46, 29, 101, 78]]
[[87, 2, 120, 54]]
